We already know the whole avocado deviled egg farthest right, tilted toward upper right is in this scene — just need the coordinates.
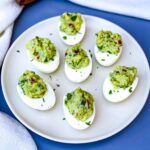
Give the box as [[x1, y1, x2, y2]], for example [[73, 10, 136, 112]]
[[103, 66, 138, 103]]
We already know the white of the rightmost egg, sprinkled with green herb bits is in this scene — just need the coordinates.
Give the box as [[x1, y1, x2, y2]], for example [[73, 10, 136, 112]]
[[103, 76, 138, 103]]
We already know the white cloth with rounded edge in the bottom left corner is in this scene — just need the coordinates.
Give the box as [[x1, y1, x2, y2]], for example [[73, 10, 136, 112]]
[[0, 112, 37, 150]]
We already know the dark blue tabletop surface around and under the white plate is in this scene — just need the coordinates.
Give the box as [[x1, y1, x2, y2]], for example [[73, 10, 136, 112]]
[[0, 0, 150, 150]]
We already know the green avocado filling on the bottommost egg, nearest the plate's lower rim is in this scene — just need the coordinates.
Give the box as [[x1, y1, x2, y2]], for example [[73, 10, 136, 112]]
[[65, 88, 94, 122]]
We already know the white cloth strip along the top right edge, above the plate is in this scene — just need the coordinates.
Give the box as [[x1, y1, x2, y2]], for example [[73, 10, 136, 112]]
[[70, 0, 150, 20]]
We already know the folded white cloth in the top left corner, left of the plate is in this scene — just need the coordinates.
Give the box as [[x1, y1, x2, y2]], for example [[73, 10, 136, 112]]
[[0, 0, 23, 65]]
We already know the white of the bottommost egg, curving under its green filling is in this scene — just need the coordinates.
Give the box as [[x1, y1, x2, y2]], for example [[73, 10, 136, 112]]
[[63, 96, 96, 130]]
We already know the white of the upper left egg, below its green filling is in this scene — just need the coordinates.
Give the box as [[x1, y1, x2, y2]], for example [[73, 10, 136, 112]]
[[27, 50, 60, 73]]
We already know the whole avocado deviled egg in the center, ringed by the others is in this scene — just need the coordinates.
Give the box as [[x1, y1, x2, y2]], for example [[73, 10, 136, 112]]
[[65, 44, 92, 83]]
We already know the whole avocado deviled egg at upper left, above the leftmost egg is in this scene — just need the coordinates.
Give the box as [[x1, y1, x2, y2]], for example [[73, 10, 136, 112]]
[[26, 36, 59, 73]]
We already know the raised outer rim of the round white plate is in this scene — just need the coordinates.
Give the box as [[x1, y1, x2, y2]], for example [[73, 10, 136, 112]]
[[1, 14, 150, 144]]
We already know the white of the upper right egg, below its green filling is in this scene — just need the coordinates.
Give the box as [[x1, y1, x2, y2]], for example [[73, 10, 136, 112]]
[[94, 45, 122, 66]]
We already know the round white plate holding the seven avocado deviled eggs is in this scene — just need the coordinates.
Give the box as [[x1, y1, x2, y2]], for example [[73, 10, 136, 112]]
[[2, 16, 150, 143]]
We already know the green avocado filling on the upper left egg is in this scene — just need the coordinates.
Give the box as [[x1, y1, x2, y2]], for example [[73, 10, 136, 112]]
[[26, 36, 56, 63]]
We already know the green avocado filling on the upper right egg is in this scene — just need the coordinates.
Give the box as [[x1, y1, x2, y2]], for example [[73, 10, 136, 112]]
[[96, 30, 122, 55]]
